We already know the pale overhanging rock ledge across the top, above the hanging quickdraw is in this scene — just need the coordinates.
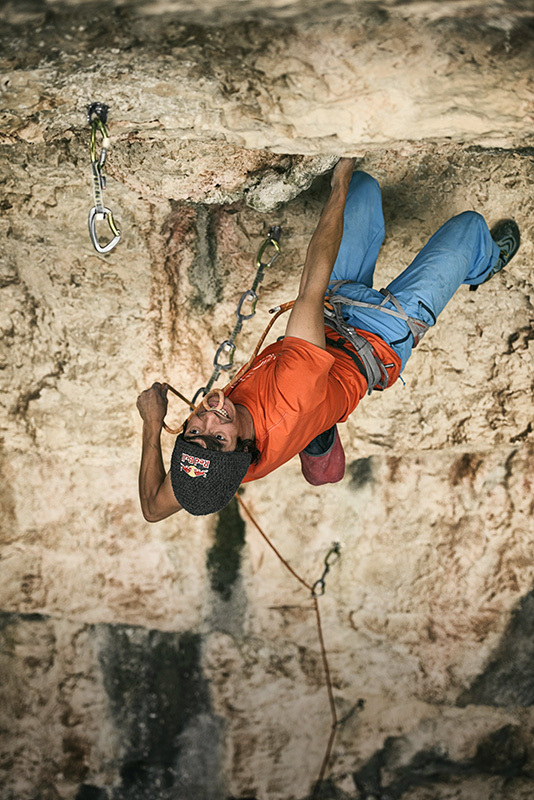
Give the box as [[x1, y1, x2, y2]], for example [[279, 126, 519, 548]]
[[3, 2, 532, 158]]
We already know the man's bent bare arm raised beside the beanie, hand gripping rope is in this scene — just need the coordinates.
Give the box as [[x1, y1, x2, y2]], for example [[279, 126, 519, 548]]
[[137, 383, 182, 522]]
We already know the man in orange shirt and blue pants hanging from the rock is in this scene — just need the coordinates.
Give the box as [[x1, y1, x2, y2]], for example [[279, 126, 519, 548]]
[[137, 158, 520, 522]]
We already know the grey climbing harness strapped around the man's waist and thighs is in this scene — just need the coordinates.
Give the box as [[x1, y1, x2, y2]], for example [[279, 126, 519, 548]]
[[324, 280, 433, 394]]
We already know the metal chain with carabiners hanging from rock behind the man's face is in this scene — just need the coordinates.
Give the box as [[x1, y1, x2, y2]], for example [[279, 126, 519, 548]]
[[191, 225, 282, 409]]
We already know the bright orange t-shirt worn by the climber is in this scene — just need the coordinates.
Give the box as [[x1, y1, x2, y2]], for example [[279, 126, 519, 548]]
[[227, 328, 401, 483]]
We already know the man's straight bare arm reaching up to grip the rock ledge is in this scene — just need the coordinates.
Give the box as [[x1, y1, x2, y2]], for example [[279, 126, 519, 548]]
[[286, 158, 354, 349]]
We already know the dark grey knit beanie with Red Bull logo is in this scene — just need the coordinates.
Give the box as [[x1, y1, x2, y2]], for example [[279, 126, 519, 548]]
[[171, 434, 252, 516]]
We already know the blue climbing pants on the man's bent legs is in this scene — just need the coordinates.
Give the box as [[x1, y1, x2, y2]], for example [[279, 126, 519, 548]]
[[331, 172, 500, 369]]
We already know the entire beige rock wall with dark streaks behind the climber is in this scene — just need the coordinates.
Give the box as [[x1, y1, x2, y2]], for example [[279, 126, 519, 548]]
[[0, 0, 534, 800]]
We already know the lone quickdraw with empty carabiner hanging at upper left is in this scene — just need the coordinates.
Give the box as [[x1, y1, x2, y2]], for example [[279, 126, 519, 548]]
[[87, 103, 121, 253]]
